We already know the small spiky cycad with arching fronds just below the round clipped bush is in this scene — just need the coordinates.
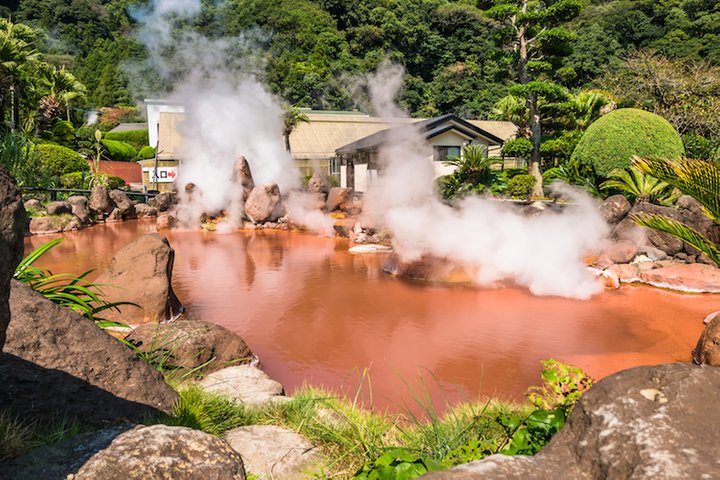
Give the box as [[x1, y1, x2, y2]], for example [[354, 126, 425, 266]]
[[600, 166, 680, 206]]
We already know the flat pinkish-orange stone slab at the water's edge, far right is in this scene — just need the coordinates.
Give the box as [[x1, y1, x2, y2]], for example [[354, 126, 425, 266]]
[[638, 263, 720, 293]]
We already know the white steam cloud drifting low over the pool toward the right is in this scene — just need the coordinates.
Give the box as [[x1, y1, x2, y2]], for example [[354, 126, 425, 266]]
[[365, 63, 607, 299]]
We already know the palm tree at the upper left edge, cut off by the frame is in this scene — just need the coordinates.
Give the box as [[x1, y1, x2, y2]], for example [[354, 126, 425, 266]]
[[0, 19, 39, 129]]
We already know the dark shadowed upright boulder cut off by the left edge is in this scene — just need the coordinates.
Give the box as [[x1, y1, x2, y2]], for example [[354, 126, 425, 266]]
[[0, 165, 25, 351]]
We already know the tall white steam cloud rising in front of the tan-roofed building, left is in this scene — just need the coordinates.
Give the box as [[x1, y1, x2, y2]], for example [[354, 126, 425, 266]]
[[135, 0, 332, 234]]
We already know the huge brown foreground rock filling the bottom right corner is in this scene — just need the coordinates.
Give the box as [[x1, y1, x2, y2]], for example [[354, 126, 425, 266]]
[[422, 363, 720, 480]]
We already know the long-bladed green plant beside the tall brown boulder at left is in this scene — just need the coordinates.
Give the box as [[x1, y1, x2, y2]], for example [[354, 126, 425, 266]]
[[13, 238, 137, 328]]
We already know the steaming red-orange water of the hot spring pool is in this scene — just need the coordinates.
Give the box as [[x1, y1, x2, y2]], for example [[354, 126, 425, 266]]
[[26, 222, 720, 411]]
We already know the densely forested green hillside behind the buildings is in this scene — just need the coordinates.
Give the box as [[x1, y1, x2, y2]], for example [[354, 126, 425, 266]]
[[5, 0, 720, 117]]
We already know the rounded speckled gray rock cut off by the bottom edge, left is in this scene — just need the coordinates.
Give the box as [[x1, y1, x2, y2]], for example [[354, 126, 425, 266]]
[[70, 425, 245, 480]]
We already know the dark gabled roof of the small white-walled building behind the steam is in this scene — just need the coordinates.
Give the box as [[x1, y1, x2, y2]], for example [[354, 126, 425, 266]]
[[336, 114, 504, 154]]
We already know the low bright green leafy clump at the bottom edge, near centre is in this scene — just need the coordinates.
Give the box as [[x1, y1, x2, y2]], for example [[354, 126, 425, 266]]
[[353, 448, 441, 480]]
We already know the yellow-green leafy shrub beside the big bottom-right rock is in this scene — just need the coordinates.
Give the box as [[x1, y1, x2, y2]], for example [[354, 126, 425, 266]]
[[525, 358, 593, 415]]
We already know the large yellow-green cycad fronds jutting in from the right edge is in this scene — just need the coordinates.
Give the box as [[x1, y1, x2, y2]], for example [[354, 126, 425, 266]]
[[633, 158, 720, 267]]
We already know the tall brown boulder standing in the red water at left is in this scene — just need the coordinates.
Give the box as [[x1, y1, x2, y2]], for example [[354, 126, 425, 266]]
[[96, 233, 183, 323]]
